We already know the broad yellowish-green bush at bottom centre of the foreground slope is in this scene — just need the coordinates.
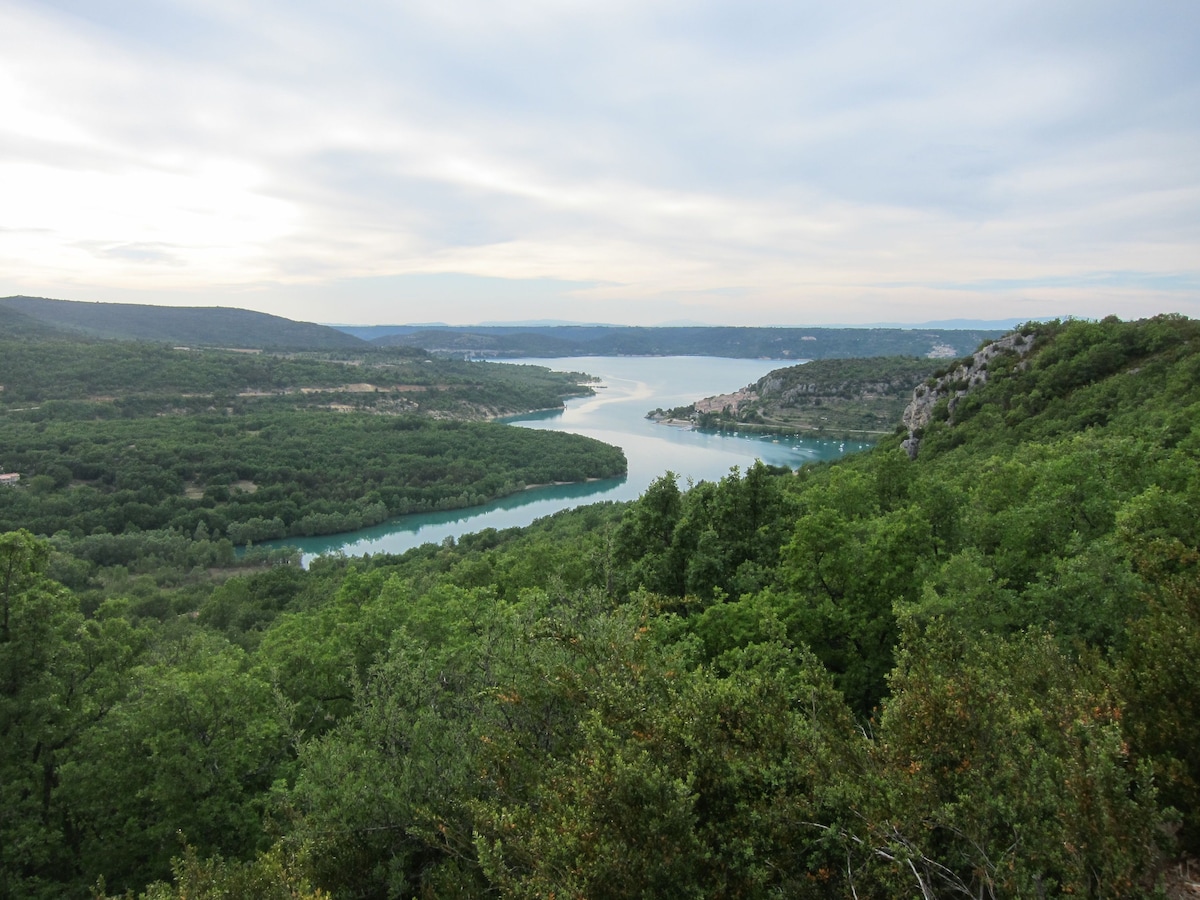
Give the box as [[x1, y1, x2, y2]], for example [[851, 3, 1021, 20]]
[[475, 612, 862, 898]]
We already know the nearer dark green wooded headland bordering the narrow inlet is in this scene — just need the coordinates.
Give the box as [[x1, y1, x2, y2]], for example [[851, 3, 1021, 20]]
[[0, 410, 625, 545]]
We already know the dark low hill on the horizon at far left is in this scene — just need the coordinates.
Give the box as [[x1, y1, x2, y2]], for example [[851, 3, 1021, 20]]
[[0, 296, 364, 350]]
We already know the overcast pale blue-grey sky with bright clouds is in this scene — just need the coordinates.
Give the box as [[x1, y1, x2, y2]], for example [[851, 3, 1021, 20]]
[[0, 0, 1200, 325]]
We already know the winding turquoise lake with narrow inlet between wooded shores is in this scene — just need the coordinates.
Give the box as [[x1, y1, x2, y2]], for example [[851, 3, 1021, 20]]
[[272, 356, 869, 557]]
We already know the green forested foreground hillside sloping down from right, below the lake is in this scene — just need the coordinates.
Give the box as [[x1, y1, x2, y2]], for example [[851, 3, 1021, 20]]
[[0, 316, 1200, 900]]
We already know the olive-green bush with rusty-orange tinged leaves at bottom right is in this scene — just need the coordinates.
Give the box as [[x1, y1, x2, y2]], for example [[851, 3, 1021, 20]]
[[860, 624, 1163, 896]]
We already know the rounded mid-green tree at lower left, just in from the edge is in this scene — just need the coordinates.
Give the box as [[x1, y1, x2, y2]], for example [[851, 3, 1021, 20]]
[[60, 634, 290, 888]]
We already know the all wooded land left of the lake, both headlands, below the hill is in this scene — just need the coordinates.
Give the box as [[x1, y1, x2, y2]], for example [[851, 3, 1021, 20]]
[[0, 336, 625, 547]]
